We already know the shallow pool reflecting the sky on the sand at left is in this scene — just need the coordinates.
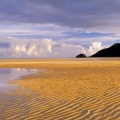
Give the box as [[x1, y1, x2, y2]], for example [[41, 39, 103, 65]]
[[0, 68, 38, 92]]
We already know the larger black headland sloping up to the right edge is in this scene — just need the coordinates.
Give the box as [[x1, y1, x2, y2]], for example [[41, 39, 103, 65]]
[[90, 43, 120, 57]]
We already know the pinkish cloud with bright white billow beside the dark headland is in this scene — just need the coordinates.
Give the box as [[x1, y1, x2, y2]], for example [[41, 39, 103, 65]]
[[52, 42, 105, 57]]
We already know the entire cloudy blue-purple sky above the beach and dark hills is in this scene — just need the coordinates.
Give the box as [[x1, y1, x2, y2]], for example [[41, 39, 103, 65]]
[[0, 0, 120, 58]]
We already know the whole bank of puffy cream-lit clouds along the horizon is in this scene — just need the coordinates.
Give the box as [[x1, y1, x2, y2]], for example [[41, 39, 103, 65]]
[[0, 37, 106, 58]]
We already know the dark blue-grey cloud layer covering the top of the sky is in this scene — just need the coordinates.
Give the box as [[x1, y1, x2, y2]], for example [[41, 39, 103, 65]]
[[0, 0, 120, 28]]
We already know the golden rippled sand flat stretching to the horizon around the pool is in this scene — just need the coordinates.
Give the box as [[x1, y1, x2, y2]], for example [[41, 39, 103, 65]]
[[0, 59, 120, 120]]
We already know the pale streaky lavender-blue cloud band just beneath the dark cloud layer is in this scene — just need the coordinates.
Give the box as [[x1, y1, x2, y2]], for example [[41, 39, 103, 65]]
[[0, 23, 119, 41]]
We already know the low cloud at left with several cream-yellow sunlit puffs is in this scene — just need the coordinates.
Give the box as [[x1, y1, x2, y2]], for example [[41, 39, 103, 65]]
[[0, 38, 52, 58]]
